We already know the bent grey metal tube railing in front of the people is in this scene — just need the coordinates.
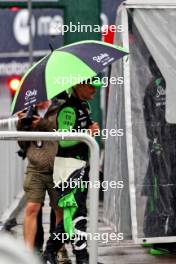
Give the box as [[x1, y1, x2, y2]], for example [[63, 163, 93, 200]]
[[0, 131, 99, 264]]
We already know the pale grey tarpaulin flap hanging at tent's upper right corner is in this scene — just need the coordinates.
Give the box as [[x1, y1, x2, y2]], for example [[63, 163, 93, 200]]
[[134, 9, 176, 123]]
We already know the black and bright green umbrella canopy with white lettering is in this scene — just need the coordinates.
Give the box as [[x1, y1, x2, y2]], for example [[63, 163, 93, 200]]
[[11, 41, 127, 113]]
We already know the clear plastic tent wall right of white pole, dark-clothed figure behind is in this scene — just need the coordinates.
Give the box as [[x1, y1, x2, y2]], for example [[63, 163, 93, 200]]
[[133, 9, 176, 242]]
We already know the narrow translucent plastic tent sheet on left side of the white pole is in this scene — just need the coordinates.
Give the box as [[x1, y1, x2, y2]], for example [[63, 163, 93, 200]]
[[104, 7, 131, 239]]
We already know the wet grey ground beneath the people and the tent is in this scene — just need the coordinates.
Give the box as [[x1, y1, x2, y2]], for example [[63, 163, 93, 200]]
[[13, 198, 176, 264]]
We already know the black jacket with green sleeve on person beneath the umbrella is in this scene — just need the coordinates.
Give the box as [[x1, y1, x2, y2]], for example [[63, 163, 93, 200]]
[[57, 95, 93, 161]]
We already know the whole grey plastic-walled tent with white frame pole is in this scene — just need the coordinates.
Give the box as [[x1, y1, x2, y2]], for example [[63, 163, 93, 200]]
[[104, 5, 176, 242]]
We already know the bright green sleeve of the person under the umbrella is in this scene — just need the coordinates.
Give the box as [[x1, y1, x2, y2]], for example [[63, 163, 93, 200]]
[[57, 107, 79, 147]]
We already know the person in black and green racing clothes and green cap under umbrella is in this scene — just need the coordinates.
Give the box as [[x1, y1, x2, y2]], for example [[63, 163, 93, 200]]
[[43, 79, 102, 264]]
